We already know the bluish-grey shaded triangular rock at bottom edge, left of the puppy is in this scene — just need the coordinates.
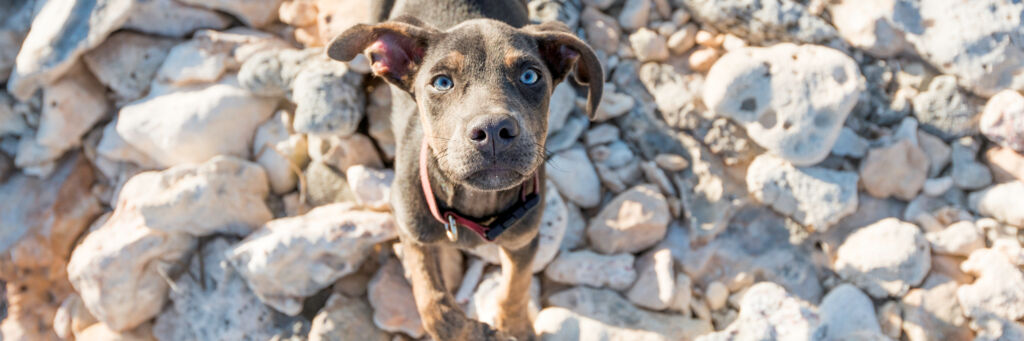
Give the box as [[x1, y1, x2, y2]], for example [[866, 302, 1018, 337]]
[[154, 239, 296, 340]]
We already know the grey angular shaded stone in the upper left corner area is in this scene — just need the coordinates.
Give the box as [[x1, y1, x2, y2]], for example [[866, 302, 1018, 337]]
[[82, 31, 176, 101]]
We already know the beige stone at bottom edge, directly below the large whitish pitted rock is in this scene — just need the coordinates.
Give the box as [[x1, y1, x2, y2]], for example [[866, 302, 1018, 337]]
[[309, 293, 391, 341]]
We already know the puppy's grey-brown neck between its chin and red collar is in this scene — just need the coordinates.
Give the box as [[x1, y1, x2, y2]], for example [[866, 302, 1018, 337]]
[[427, 148, 521, 218]]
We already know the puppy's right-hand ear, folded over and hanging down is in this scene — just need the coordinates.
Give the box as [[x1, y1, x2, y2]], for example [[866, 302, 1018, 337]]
[[522, 22, 604, 118]]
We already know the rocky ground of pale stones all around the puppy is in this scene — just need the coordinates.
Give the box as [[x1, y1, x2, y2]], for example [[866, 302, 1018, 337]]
[[0, 0, 1024, 341]]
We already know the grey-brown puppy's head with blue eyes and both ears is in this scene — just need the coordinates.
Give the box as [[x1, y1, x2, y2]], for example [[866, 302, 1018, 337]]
[[328, 16, 603, 190]]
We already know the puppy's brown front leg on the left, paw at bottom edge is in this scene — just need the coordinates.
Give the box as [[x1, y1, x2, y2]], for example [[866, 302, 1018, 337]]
[[401, 239, 512, 340]]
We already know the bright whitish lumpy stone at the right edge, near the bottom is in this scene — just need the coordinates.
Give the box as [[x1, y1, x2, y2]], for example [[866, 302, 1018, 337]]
[[956, 249, 1024, 321]]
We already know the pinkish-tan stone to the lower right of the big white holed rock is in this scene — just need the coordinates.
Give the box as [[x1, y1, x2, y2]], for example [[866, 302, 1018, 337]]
[[860, 140, 929, 201]]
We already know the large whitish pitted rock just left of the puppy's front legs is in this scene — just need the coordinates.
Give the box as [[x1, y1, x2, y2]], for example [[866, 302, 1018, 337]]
[[228, 204, 397, 315]]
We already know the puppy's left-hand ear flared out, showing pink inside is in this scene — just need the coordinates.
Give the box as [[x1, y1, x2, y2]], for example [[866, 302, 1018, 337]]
[[327, 16, 439, 91]]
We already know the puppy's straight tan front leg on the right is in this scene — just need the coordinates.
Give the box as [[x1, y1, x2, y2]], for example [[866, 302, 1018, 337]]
[[495, 238, 538, 341]]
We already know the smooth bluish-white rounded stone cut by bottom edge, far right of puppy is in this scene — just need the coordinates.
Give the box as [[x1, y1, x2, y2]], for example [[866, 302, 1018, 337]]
[[818, 284, 887, 340]]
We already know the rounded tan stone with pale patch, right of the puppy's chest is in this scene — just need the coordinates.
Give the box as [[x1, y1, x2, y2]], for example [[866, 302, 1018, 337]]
[[587, 185, 671, 254]]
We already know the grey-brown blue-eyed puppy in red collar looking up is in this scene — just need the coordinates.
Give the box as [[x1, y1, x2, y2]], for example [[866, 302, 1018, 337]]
[[327, 0, 603, 340]]
